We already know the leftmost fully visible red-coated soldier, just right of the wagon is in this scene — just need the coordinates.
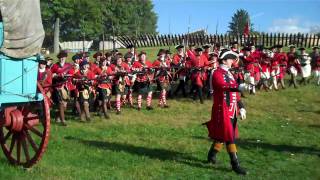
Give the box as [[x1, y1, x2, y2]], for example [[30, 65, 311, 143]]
[[51, 51, 72, 126]]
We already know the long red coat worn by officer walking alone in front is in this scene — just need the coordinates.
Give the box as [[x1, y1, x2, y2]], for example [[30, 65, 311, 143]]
[[207, 67, 240, 142]]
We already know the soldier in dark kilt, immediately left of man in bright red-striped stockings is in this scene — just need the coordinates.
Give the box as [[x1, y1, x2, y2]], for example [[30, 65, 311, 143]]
[[132, 51, 154, 111]]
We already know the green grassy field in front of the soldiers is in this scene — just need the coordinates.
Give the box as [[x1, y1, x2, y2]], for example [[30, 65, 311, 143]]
[[0, 81, 320, 179]]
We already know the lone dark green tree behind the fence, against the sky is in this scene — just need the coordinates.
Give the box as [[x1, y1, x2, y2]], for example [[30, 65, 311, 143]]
[[228, 9, 254, 35]]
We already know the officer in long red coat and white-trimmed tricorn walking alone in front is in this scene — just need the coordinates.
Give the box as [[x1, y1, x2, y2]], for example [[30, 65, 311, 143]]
[[206, 50, 246, 175]]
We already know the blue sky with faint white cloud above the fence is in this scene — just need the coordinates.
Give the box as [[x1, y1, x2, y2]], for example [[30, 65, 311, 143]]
[[153, 0, 320, 34]]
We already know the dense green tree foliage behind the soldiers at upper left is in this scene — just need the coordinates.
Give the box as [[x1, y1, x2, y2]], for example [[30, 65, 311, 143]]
[[41, 0, 157, 46]]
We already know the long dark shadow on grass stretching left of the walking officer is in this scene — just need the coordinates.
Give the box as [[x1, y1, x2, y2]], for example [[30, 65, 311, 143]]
[[65, 136, 211, 169]]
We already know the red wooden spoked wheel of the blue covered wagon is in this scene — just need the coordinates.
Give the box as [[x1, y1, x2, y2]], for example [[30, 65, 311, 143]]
[[0, 83, 50, 168]]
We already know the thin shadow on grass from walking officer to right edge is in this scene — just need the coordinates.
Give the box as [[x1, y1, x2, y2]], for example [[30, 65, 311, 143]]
[[237, 139, 320, 156]]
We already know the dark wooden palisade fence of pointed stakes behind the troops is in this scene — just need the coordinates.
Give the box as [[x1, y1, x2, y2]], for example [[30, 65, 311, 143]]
[[117, 33, 320, 48]]
